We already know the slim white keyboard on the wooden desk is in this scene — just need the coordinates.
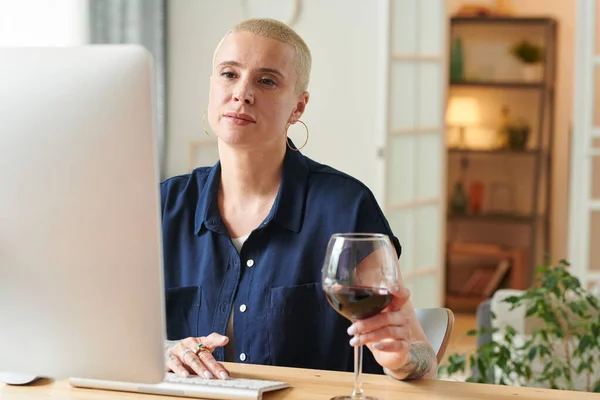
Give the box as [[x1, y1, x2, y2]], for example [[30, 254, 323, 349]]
[[69, 372, 290, 400]]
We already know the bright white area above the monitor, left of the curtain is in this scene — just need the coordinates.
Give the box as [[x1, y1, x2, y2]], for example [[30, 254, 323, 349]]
[[0, 0, 88, 46]]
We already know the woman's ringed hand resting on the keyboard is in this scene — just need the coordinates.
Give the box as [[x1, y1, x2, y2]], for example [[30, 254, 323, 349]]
[[167, 332, 229, 379]]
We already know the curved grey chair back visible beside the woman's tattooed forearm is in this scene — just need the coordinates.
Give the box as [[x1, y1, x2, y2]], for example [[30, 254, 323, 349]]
[[415, 308, 454, 363]]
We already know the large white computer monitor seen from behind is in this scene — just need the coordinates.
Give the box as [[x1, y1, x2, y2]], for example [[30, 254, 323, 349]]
[[0, 45, 165, 383]]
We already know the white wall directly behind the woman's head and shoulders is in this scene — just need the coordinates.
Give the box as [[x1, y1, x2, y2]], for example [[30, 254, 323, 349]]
[[167, 0, 386, 204]]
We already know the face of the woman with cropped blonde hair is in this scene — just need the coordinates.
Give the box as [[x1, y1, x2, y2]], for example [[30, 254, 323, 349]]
[[208, 32, 308, 148]]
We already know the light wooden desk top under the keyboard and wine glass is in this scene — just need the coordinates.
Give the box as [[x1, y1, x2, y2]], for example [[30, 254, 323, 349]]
[[0, 363, 599, 400]]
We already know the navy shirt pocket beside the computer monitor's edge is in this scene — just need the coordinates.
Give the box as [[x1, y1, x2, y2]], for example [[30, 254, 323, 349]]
[[165, 286, 202, 340]]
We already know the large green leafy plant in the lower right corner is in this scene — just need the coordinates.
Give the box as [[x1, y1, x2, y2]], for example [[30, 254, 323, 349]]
[[439, 261, 600, 392]]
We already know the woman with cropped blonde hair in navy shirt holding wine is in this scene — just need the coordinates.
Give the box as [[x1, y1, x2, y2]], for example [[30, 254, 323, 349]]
[[161, 19, 437, 379]]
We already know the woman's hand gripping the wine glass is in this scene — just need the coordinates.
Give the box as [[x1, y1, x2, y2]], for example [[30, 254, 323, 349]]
[[348, 286, 411, 370]]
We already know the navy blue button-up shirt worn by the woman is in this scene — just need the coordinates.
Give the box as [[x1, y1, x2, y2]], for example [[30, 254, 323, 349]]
[[160, 149, 401, 373]]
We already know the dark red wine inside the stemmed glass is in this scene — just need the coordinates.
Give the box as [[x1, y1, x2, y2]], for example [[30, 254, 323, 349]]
[[325, 286, 392, 319]]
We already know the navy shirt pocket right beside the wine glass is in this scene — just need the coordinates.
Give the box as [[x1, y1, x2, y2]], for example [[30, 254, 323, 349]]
[[267, 283, 338, 368]]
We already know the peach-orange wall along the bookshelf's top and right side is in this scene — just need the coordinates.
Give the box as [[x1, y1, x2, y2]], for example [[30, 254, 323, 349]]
[[448, 0, 577, 260]]
